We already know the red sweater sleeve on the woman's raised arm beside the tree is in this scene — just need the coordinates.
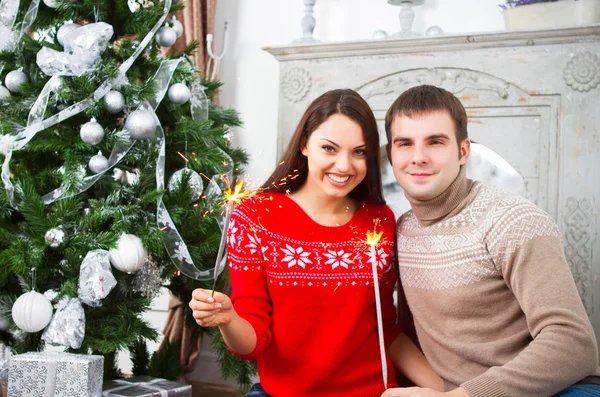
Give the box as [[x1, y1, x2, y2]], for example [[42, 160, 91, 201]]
[[227, 206, 272, 360]]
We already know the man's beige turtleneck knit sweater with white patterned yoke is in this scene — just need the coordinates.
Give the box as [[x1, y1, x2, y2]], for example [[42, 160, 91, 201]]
[[397, 167, 600, 397]]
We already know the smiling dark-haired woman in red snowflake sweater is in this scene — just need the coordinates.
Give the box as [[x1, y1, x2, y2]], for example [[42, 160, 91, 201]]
[[190, 90, 442, 397]]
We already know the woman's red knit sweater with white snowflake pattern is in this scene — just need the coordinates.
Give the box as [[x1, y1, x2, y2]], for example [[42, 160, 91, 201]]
[[227, 193, 402, 397]]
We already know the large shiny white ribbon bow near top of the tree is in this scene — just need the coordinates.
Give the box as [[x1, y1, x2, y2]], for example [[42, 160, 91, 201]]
[[36, 22, 113, 76]]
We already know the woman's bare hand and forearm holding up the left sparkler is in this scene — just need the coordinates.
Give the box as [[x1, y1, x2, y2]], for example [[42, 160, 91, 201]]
[[189, 288, 257, 355]]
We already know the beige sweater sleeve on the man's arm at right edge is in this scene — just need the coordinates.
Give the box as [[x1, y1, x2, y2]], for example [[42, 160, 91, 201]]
[[461, 199, 598, 397]]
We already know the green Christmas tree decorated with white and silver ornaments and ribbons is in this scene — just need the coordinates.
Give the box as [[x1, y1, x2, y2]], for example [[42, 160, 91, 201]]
[[0, 0, 253, 386]]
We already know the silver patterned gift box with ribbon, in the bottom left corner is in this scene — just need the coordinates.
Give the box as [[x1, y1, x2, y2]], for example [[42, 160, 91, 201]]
[[8, 353, 104, 397]]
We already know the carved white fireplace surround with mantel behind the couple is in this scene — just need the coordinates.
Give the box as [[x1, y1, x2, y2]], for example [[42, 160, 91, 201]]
[[265, 25, 600, 346]]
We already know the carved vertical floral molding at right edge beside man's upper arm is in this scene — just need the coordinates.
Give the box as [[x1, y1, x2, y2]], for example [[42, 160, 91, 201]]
[[564, 197, 594, 314]]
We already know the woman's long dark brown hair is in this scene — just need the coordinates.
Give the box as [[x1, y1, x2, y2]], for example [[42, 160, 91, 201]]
[[261, 89, 385, 204]]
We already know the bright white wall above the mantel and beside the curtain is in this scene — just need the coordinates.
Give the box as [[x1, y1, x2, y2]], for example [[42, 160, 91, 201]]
[[215, 0, 504, 187]]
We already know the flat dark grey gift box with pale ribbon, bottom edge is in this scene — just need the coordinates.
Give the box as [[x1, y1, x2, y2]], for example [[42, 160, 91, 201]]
[[102, 376, 192, 397]]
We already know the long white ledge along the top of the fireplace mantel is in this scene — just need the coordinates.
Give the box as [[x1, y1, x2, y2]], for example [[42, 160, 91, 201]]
[[263, 25, 600, 61]]
